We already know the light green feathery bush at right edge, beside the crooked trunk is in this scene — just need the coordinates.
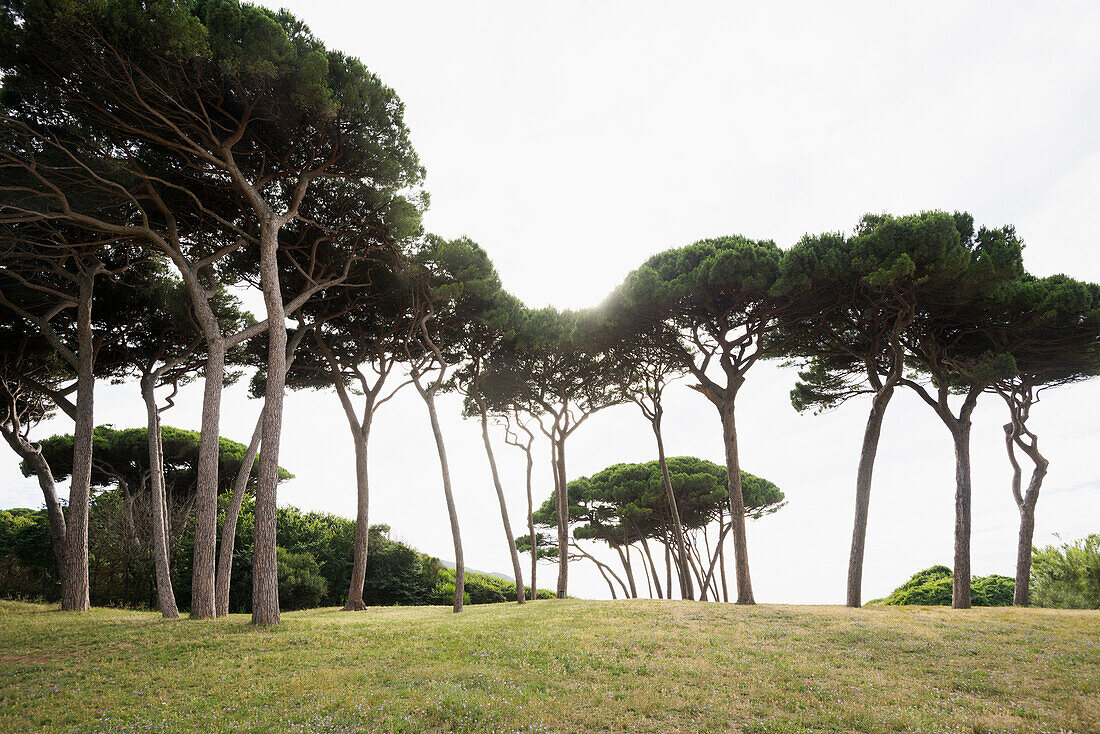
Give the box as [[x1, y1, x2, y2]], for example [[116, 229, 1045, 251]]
[[1031, 535, 1100, 610]]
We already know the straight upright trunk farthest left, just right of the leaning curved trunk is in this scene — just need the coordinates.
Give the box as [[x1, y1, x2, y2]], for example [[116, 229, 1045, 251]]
[[62, 276, 96, 612]]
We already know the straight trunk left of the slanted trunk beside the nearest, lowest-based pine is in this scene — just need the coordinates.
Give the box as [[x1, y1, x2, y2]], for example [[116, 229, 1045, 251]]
[[190, 335, 226, 620]]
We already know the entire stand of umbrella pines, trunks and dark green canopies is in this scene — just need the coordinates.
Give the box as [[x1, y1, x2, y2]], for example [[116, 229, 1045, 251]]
[[0, 0, 1100, 624]]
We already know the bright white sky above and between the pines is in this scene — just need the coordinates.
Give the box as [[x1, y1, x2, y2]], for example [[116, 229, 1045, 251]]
[[0, 0, 1100, 603]]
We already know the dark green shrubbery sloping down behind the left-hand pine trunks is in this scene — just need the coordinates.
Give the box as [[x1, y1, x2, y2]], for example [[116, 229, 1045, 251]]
[[0, 499, 553, 612]]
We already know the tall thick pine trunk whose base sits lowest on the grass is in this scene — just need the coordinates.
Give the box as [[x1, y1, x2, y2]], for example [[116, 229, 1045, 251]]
[[251, 225, 287, 625]]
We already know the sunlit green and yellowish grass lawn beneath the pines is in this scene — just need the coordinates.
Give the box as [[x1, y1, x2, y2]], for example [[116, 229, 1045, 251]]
[[0, 600, 1100, 734]]
